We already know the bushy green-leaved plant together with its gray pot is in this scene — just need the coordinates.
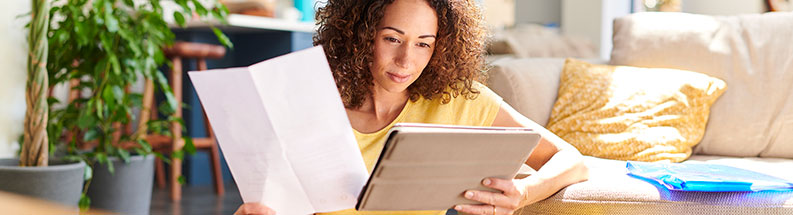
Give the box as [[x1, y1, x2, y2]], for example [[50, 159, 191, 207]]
[[47, 0, 231, 214]]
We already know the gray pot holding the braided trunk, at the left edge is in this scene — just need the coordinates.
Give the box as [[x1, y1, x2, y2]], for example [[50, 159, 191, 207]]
[[0, 158, 85, 207]]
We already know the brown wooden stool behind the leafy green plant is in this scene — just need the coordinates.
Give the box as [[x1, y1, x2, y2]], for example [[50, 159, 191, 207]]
[[152, 42, 226, 201]]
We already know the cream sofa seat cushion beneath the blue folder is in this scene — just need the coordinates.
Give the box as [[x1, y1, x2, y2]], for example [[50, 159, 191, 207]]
[[515, 155, 793, 215]]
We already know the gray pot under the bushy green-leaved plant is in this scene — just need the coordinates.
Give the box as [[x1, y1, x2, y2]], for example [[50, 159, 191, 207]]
[[88, 155, 154, 214]]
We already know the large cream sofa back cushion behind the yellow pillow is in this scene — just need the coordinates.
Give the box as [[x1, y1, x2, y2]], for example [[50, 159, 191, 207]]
[[610, 13, 793, 158]]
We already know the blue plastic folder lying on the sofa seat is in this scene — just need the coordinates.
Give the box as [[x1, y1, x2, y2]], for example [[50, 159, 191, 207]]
[[626, 161, 793, 192]]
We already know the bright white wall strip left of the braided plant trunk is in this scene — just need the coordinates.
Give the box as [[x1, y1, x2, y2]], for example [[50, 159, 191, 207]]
[[0, 0, 30, 158]]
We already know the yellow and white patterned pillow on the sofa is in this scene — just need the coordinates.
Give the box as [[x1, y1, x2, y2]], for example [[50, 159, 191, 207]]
[[547, 59, 726, 162]]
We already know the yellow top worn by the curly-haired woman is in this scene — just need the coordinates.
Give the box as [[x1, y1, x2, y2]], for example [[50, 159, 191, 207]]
[[317, 82, 501, 215]]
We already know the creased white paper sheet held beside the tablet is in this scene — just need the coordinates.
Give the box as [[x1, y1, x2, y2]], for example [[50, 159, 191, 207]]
[[188, 47, 369, 214]]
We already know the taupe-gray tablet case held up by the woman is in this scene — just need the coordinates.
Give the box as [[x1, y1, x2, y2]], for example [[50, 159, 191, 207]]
[[355, 124, 540, 211]]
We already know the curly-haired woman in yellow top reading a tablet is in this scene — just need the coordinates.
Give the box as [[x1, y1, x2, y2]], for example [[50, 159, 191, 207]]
[[237, 0, 587, 215]]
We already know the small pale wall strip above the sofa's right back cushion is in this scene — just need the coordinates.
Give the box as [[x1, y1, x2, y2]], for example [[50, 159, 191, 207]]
[[681, 0, 766, 15]]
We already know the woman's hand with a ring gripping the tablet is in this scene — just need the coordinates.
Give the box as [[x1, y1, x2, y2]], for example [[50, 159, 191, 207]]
[[454, 178, 528, 215]]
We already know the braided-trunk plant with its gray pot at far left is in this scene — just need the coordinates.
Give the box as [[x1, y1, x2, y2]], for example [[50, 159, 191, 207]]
[[0, 0, 85, 206]]
